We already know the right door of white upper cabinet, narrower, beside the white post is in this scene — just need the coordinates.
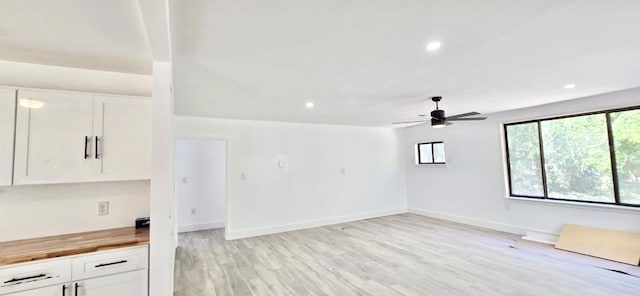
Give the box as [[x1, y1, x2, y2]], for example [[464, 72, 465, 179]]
[[93, 96, 151, 181]]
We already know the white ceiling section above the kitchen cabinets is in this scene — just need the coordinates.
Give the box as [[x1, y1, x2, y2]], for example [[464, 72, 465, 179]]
[[0, 0, 151, 74]]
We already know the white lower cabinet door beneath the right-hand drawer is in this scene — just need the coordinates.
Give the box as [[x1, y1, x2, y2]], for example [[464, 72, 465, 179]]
[[74, 270, 148, 296]]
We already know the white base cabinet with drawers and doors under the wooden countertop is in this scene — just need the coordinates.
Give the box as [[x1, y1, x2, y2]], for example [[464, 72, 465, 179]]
[[0, 246, 149, 296]]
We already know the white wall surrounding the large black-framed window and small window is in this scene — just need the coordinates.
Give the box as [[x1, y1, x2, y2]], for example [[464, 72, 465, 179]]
[[404, 89, 640, 241]]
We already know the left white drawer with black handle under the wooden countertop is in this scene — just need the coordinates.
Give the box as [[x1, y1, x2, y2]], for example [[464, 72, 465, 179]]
[[0, 259, 71, 295]]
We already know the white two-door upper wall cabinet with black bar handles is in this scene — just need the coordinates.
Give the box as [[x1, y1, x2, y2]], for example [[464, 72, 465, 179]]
[[13, 90, 151, 185]]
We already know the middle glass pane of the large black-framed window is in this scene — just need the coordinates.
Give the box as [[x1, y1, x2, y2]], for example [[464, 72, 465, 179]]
[[541, 114, 615, 203]]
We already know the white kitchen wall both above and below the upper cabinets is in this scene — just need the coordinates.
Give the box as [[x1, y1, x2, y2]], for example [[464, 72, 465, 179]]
[[0, 61, 151, 241]]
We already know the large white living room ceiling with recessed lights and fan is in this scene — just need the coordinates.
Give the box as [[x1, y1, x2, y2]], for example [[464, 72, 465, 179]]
[[170, 0, 640, 126]]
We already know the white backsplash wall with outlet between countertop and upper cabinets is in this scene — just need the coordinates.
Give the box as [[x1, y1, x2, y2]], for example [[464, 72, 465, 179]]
[[0, 181, 149, 241]]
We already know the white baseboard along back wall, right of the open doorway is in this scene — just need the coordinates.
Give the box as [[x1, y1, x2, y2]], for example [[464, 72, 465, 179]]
[[225, 208, 407, 240]]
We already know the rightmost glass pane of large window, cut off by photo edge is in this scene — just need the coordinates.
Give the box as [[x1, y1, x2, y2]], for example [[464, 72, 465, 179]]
[[610, 110, 640, 205]]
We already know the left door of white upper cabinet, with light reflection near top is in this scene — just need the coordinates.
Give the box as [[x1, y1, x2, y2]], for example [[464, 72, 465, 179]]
[[13, 90, 93, 184]]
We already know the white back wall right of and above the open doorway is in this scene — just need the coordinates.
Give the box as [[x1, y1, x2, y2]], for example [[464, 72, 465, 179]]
[[174, 117, 406, 239]]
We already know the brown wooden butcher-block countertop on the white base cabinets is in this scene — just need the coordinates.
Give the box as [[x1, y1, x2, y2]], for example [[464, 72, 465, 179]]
[[0, 227, 149, 266]]
